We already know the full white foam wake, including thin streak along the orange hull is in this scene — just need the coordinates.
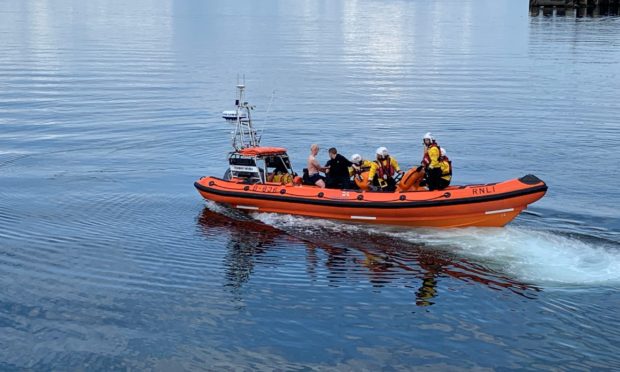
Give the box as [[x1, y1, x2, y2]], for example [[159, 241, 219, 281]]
[[253, 213, 620, 286]]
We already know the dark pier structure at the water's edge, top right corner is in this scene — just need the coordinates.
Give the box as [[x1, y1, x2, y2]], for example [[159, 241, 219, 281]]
[[530, 0, 620, 17]]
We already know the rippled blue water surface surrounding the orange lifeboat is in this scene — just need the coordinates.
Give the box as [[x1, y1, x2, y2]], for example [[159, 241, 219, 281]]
[[0, 0, 620, 371]]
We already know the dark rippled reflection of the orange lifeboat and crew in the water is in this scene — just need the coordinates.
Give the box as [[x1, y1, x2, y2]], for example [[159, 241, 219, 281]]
[[197, 207, 540, 306]]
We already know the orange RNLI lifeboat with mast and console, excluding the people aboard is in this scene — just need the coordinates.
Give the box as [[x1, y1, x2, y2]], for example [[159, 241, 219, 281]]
[[199, 84, 547, 227]]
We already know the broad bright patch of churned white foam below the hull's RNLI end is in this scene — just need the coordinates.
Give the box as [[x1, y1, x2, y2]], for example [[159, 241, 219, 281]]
[[400, 227, 620, 285]]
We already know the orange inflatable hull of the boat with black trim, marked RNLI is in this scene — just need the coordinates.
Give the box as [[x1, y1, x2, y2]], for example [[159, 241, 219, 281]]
[[194, 175, 547, 227]]
